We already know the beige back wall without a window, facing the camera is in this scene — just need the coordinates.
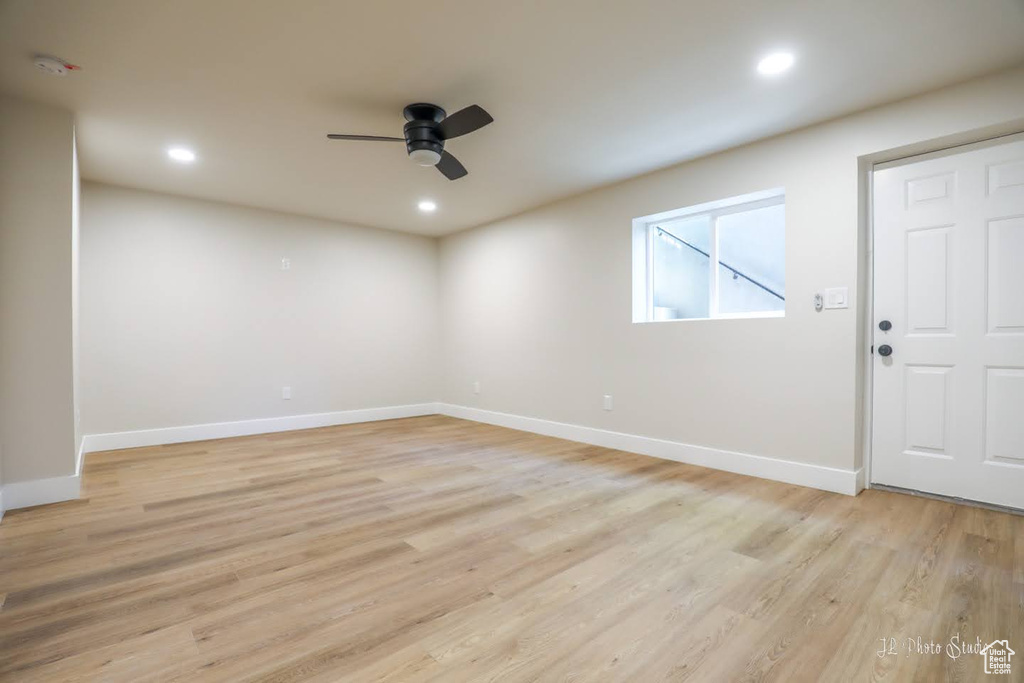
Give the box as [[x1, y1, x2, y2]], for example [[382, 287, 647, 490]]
[[81, 182, 439, 434]]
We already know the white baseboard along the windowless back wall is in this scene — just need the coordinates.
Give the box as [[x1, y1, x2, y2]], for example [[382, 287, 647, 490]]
[[82, 403, 437, 453]]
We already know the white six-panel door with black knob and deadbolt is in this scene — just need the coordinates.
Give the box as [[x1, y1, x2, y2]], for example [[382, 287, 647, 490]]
[[871, 135, 1024, 508]]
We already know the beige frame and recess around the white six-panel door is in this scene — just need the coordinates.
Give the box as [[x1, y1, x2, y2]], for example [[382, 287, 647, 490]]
[[858, 122, 1024, 488]]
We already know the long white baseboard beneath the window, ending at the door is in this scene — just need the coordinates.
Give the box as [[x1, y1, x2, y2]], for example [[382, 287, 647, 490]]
[[437, 403, 864, 496]]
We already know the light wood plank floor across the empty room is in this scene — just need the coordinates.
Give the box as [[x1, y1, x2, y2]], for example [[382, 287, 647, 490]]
[[0, 417, 1024, 683]]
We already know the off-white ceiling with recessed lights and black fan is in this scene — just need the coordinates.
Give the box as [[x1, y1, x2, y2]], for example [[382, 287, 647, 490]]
[[0, 0, 1024, 234]]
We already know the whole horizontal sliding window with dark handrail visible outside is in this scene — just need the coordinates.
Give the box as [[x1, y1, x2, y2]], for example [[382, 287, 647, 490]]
[[633, 189, 785, 323]]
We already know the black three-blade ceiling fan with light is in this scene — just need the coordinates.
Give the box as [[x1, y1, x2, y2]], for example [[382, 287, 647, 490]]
[[328, 102, 494, 180]]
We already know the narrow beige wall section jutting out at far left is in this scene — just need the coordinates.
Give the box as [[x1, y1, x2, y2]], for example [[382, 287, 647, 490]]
[[0, 97, 75, 484]]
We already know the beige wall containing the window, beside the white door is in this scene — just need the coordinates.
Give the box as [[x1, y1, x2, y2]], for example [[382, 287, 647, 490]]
[[440, 63, 1024, 469]]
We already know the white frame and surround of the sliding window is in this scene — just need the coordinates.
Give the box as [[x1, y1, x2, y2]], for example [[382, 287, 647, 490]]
[[633, 187, 785, 323]]
